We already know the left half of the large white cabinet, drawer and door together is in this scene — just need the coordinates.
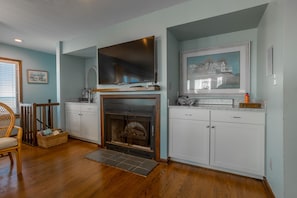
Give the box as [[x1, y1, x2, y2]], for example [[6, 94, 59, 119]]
[[169, 109, 209, 164]]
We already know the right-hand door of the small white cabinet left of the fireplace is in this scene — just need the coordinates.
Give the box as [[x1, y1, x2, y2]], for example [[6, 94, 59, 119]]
[[80, 111, 99, 142]]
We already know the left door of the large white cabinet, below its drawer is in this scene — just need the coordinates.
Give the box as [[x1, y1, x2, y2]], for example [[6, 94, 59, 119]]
[[169, 118, 209, 165]]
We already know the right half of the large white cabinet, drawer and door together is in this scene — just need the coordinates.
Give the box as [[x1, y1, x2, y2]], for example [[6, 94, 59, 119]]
[[210, 110, 265, 177]]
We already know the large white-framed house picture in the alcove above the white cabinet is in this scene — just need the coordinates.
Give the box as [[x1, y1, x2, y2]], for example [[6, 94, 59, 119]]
[[181, 42, 250, 95]]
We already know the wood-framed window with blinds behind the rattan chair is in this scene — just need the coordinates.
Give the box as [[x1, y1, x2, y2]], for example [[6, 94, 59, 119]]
[[0, 57, 22, 114]]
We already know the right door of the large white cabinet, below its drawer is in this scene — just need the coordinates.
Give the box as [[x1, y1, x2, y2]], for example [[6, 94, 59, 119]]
[[210, 121, 264, 176]]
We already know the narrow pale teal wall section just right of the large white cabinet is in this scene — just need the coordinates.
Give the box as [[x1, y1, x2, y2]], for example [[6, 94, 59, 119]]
[[258, 1, 284, 197]]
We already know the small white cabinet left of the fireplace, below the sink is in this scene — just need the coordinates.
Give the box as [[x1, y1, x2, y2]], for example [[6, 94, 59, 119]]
[[65, 102, 100, 144]]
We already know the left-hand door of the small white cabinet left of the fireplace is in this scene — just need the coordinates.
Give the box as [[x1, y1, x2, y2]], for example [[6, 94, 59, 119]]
[[66, 111, 80, 137]]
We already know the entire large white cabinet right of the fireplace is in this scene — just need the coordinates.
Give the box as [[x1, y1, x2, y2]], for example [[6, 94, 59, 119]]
[[169, 107, 265, 178]]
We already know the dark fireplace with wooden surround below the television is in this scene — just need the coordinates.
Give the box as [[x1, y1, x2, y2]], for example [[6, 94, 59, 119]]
[[101, 95, 159, 159]]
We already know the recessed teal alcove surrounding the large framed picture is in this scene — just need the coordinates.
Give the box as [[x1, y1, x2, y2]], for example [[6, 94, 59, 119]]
[[167, 4, 268, 105]]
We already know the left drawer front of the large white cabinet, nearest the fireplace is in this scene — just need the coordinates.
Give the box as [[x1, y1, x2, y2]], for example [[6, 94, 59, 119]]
[[169, 108, 209, 121]]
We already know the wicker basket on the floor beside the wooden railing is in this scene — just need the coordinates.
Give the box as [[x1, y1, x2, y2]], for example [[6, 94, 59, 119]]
[[37, 132, 68, 148]]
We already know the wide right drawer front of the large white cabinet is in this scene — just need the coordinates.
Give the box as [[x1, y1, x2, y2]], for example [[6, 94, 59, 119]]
[[211, 110, 265, 124]]
